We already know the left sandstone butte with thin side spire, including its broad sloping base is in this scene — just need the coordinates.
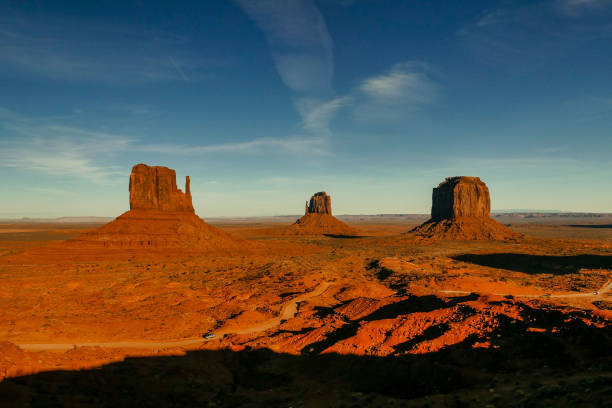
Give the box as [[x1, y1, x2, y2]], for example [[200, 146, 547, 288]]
[[67, 164, 246, 249]]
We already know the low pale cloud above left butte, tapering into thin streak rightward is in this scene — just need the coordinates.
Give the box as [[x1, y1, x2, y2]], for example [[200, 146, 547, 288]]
[[0, 108, 333, 184]]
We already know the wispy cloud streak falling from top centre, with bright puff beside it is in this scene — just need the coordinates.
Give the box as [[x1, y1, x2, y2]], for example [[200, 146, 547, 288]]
[[235, 0, 437, 132]]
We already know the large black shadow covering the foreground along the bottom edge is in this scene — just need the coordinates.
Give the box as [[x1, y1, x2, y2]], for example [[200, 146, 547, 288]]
[[0, 304, 612, 408]]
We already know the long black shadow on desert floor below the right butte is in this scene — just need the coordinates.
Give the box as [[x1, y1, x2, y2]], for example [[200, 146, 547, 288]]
[[452, 253, 612, 275]]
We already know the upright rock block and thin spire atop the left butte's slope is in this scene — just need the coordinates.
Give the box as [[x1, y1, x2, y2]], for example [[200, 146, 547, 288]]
[[130, 163, 194, 213]]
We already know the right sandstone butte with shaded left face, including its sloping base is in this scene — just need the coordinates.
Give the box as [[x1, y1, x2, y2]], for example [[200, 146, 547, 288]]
[[410, 176, 522, 241]]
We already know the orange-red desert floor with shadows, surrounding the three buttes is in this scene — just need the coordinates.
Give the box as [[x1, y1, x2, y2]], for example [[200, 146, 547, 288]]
[[0, 215, 612, 407]]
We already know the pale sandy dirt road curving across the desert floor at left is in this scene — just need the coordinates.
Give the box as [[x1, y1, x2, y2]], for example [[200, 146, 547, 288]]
[[17, 282, 331, 351]]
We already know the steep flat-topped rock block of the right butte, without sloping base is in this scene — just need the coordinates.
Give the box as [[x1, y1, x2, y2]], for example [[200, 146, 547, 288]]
[[431, 176, 491, 221]]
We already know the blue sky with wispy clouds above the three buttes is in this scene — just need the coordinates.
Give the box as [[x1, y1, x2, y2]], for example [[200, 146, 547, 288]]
[[0, 0, 612, 217]]
